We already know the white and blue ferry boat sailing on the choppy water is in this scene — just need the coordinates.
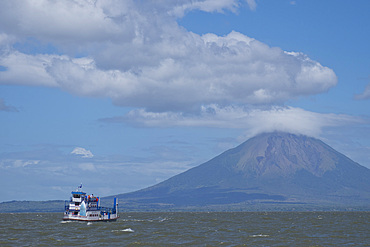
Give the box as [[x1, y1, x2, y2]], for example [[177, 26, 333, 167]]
[[63, 184, 119, 221]]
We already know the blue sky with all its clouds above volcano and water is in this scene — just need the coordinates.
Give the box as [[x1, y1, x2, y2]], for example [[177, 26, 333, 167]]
[[0, 0, 370, 202]]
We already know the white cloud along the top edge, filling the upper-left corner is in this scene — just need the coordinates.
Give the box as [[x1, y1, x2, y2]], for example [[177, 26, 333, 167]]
[[0, 0, 240, 44]]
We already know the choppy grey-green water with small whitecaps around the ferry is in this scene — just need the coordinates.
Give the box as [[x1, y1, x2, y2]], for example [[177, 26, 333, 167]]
[[0, 212, 370, 246]]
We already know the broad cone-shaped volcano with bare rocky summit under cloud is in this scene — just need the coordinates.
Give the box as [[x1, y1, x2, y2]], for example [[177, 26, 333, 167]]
[[112, 132, 370, 210]]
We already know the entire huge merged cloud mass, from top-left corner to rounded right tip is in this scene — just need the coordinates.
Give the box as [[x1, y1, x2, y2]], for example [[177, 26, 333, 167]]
[[0, 0, 337, 112]]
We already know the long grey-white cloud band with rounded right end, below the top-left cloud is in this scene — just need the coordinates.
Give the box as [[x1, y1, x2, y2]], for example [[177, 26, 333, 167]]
[[0, 32, 337, 111]]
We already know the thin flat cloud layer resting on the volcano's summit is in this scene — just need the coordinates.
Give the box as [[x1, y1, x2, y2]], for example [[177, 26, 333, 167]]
[[102, 105, 364, 137]]
